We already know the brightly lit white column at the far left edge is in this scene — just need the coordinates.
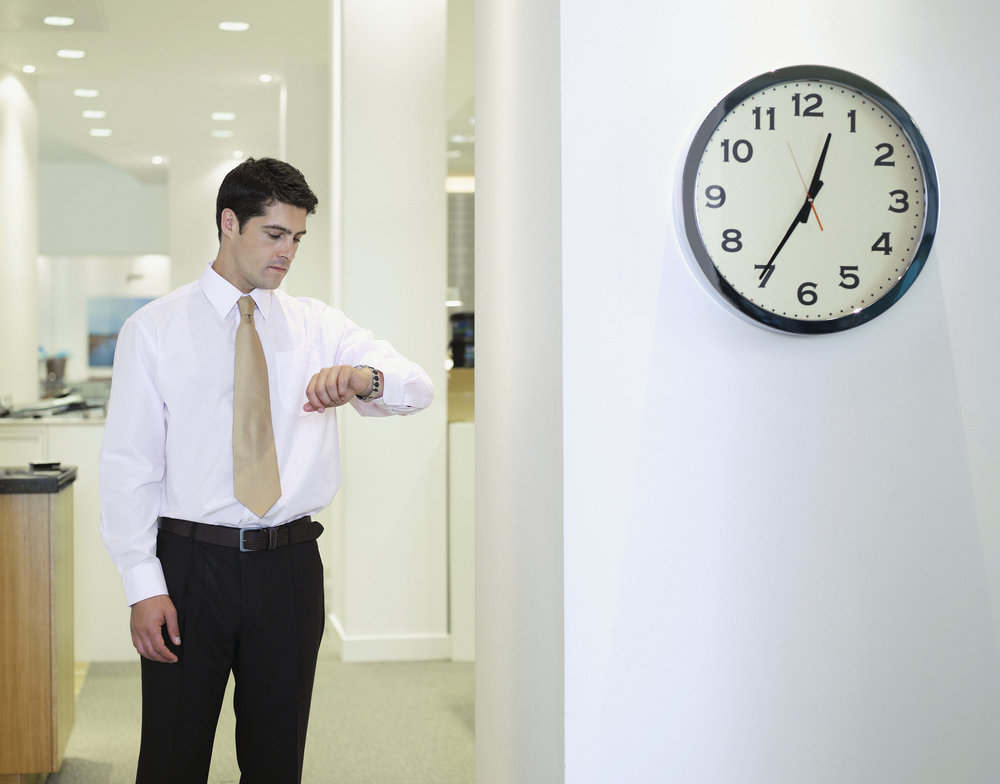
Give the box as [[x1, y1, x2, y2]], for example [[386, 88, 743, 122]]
[[0, 70, 39, 403]]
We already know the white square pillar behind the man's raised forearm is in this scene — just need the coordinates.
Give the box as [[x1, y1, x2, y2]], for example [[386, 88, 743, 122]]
[[328, 0, 451, 660]]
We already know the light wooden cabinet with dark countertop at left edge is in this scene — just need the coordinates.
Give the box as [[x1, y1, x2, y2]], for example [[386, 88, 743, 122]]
[[0, 468, 76, 782]]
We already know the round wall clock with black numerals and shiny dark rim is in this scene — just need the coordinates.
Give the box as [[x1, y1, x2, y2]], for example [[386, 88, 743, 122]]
[[681, 66, 937, 333]]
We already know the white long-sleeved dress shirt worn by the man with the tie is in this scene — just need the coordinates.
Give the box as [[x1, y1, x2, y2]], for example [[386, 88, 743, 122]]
[[99, 266, 434, 605]]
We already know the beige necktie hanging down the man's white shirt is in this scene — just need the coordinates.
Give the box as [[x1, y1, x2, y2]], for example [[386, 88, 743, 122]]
[[233, 296, 281, 517]]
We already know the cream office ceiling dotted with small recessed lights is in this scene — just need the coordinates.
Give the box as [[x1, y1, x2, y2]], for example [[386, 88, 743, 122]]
[[0, 0, 475, 181]]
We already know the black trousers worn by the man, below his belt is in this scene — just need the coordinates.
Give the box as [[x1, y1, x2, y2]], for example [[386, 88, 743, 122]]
[[136, 530, 326, 784]]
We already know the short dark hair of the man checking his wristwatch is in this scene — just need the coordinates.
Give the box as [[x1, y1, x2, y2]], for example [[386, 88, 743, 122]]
[[215, 158, 319, 240]]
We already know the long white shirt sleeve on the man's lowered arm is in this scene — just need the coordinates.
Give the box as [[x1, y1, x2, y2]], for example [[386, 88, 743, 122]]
[[98, 319, 167, 605]]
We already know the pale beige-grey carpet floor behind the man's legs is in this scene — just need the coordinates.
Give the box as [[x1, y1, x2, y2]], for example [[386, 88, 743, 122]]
[[45, 650, 475, 784]]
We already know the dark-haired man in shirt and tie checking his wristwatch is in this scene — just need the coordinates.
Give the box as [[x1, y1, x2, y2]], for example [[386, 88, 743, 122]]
[[100, 158, 433, 784]]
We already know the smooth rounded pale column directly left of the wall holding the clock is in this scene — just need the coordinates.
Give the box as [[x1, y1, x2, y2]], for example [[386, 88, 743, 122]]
[[476, 0, 564, 784]]
